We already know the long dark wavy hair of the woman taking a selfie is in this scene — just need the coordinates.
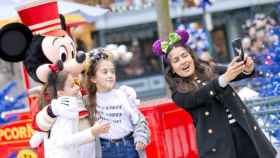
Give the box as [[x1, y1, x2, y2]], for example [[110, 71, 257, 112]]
[[165, 43, 217, 93]]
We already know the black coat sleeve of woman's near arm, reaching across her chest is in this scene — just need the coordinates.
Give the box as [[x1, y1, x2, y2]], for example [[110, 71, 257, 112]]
[[172, 78, 224, 110]]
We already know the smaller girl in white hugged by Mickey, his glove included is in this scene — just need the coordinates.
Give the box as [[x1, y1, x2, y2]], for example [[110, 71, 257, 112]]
[[30, 72, 110, 158]]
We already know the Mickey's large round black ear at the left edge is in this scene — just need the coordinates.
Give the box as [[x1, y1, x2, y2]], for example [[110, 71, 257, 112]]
[[0, 23, 33, 62]]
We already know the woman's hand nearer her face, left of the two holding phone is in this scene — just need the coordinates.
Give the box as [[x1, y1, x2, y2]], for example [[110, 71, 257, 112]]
[[224, 57, 245, 84]]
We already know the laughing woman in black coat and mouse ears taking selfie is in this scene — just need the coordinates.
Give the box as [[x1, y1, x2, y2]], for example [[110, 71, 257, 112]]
[[153, 30, 276, 158]]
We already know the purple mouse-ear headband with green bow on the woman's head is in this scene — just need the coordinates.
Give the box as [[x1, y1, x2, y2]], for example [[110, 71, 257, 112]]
[[153, 29, 189, 56]]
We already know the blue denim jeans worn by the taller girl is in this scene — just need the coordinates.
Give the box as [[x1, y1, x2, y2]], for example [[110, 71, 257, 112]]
[[100, 137, 139, 158]]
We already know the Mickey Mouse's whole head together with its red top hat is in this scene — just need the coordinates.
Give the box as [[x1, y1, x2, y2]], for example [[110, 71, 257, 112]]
[[0, 0, 86, 83]]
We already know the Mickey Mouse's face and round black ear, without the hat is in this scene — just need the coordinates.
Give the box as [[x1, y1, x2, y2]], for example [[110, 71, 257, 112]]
[[0, 23, 85, 83]]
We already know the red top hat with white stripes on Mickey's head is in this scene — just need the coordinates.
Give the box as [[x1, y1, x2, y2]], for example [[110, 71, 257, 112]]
[[17, 0, 62, 34]]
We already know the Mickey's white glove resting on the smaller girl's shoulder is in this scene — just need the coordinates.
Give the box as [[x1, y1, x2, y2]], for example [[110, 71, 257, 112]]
[[51, 97, 83, 119]]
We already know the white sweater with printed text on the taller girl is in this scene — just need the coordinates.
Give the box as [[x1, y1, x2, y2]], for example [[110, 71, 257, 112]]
[[96, 89, 139, 139]]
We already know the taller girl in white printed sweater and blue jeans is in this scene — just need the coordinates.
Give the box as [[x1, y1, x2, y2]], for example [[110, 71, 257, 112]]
[[86, 49, 149, 158]]
